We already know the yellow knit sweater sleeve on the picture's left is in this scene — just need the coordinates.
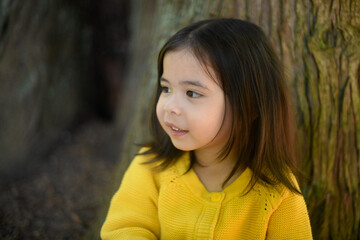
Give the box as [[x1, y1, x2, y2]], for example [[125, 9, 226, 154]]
[[100, 153, 160, 240]]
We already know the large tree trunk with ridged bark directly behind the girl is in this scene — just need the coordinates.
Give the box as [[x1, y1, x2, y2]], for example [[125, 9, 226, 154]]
[[119, 0, 360, 239]]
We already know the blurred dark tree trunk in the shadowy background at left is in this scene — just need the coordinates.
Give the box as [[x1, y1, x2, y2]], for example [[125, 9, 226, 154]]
[[0, 0, 94, 176]]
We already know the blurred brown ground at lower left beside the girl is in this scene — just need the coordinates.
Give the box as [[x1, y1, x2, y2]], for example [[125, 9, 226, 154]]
[[0, 120, 121, 240]]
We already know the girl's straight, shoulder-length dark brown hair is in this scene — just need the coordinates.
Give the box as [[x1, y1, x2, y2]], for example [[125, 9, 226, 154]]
[[141, 19, 300, 193]]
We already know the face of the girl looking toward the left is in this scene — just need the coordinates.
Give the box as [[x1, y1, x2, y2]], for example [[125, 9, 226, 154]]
[[156, 50, 231, 151]]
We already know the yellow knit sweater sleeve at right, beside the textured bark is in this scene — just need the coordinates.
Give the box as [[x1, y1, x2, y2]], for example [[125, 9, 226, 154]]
[[266, 190, 313, 240]]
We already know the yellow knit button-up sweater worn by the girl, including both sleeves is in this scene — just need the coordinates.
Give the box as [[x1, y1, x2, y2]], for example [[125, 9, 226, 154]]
[[101, 153, 312, 240]]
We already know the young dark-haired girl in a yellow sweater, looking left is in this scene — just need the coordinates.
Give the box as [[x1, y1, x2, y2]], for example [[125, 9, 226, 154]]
[[101, 19, 312, 239]]
